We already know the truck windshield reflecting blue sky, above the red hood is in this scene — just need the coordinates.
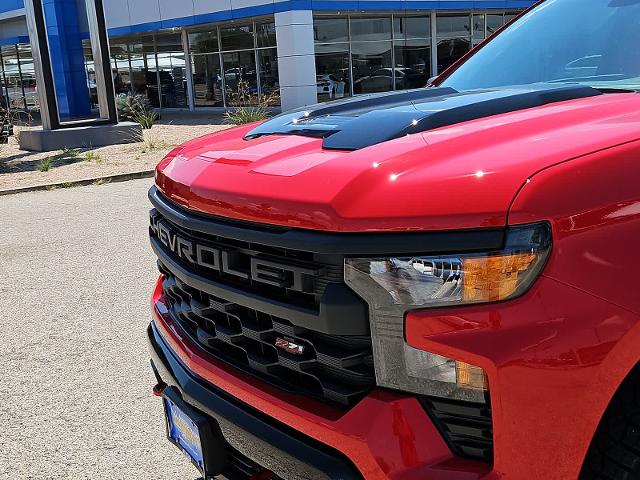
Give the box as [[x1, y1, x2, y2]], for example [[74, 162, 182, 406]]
[[440, 0, 640, 91]]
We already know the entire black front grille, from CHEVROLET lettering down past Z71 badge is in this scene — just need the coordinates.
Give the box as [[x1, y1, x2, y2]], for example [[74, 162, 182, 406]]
[[150, 202, 375, 408]]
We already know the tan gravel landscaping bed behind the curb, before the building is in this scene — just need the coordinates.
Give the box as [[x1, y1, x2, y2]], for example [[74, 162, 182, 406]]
[[0, 113, 228, 191]]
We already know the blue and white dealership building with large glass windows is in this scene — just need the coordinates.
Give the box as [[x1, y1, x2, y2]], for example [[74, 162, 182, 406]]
[[0, 0, 533, 117]]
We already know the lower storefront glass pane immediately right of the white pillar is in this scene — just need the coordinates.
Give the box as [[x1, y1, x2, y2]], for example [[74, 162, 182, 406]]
[[316, 43, 351, 102]]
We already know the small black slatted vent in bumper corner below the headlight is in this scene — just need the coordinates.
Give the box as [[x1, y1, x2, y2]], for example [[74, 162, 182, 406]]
[[421, 397, 493, 463]]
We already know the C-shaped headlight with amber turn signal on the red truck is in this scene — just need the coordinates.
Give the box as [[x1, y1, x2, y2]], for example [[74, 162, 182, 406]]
[[345, 223, 551, 402]]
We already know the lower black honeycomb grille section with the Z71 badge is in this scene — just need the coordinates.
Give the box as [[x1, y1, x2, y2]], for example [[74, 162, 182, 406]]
[[159, 263, 375, 407]]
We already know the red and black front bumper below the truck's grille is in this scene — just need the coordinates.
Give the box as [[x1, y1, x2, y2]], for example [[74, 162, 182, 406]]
[[149, 289, 491, 480]]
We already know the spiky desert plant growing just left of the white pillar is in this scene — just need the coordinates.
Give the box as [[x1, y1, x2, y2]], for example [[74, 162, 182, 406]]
[[224, 80, 280, 125]]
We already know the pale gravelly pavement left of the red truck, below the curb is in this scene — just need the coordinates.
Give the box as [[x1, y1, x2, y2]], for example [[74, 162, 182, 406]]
[[0, 180, 197, 480]]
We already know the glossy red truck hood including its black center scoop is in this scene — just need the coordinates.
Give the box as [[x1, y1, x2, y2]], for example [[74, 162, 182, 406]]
[[156, 87, 640, 232]]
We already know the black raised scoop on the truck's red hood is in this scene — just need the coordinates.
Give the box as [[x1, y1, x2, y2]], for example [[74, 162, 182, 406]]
[[245, 84, 601, 150]]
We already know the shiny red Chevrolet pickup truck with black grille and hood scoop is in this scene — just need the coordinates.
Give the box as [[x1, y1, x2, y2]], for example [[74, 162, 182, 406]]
[[148, 0, 640, 480]]
